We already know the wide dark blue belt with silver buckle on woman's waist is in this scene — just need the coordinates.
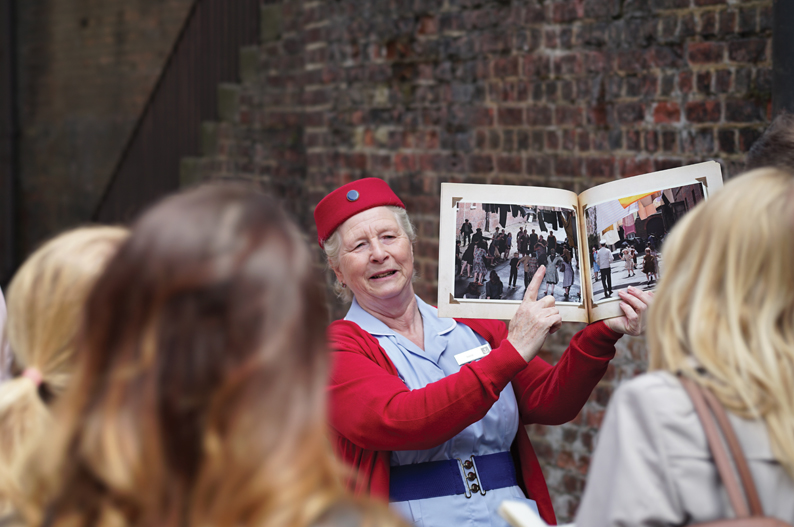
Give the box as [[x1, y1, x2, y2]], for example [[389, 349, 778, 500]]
[[389, 452, 518, 501]]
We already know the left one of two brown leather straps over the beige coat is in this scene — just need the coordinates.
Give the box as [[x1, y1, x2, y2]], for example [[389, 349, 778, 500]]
[[679, 376, 750, 518]]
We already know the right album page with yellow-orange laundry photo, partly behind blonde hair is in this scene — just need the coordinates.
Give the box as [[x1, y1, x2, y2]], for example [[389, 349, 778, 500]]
[[579, 161, 722, 322]]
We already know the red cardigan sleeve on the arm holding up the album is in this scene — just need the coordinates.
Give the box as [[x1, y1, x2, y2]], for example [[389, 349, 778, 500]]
[[513, 322, 621, 425]]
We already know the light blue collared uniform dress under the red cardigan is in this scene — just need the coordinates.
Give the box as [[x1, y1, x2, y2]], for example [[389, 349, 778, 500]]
[[345, 296, 537, 527]]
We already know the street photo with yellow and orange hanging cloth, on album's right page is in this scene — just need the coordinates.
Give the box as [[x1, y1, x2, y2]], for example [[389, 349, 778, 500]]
[[585, 183, 704, 303]]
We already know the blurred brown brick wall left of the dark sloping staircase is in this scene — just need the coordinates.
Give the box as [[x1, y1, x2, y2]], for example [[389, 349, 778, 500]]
[[16, 0, 192, 257]]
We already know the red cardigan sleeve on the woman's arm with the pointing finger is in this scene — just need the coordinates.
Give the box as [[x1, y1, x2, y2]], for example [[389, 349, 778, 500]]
[[329, 326, 526, 450]]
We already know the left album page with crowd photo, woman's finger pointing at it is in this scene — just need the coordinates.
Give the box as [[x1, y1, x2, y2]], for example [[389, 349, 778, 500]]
[[438, 183, 588, 322]]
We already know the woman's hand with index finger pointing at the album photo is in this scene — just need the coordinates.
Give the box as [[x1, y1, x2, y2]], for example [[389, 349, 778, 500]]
[[507, 265, 562, 362]]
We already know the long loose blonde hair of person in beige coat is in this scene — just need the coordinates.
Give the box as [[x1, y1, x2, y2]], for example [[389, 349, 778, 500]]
[[648, 168, 794, 477]]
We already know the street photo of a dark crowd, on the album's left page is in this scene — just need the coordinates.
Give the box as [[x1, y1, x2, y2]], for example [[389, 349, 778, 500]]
[[454, 201, 582, 304]]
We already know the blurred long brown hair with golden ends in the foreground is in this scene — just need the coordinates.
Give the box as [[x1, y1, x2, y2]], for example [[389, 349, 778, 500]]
[[18, 184, 402, 527]]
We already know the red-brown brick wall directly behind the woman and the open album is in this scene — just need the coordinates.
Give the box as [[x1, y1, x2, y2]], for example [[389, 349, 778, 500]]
[[193, 0, 772, 521]]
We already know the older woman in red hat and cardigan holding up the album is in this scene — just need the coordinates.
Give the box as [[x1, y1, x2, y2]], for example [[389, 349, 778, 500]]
[[314, 178, 651, 527]]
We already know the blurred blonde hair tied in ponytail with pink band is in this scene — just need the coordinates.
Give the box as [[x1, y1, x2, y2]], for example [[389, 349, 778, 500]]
[[0, 227, 128, 512]]
